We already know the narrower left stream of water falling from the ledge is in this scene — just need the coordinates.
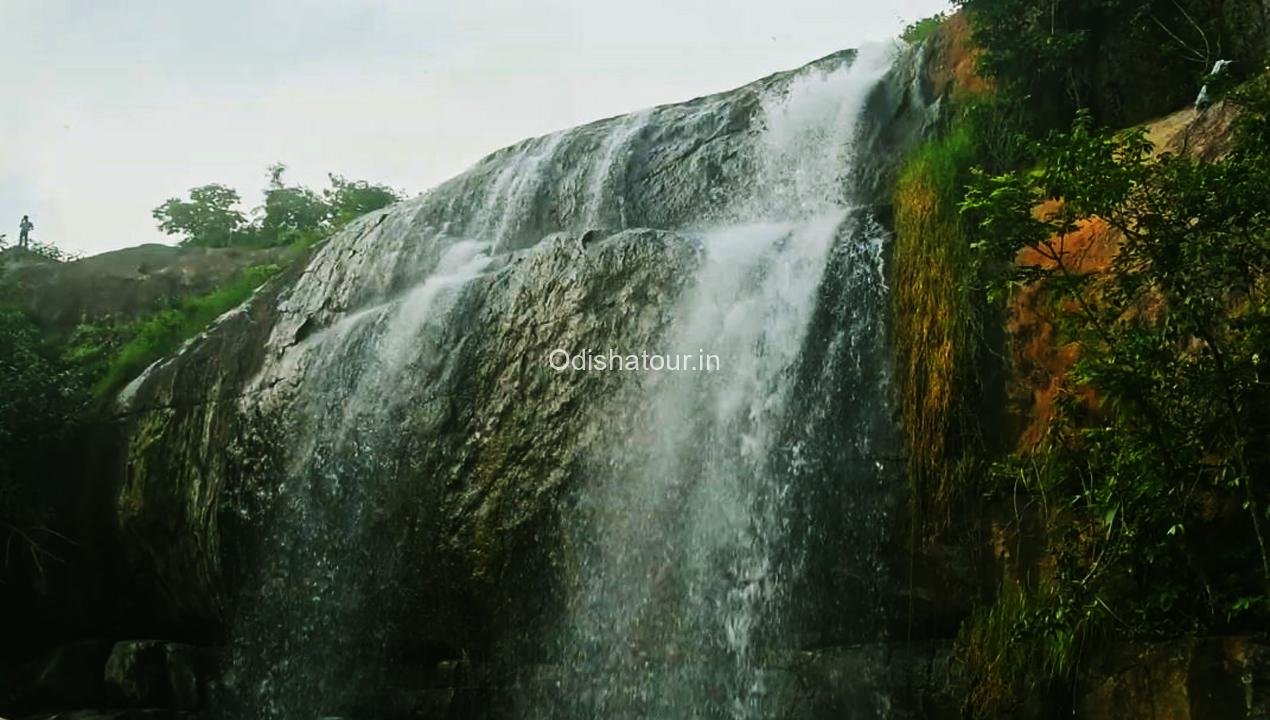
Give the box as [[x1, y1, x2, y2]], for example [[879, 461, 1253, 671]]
[[232, 241, 491, 719]]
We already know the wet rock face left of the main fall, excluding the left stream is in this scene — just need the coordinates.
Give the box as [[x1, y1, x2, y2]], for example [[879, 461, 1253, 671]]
[[116, 40, 927, 647]]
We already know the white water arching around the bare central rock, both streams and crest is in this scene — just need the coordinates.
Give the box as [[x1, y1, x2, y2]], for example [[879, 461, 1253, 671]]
[[226, 40, 893, 720]]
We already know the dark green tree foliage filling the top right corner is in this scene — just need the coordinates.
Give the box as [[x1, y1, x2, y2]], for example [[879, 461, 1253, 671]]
[[956, 0, 1265, 127]]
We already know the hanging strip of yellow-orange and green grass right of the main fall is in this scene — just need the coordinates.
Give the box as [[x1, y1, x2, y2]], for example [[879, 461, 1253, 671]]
[[893, 87, 1027, 537]]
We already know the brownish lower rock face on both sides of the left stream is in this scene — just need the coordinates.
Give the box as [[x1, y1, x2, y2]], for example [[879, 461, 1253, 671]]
[[116, 230, 699, 646]]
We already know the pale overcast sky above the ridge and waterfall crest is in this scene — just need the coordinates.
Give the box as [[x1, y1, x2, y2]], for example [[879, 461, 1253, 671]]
[[0, 0, 947, 254]]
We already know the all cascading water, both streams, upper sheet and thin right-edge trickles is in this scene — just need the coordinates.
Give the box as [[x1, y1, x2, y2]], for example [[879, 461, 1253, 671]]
[[226, 38, 924, 720]]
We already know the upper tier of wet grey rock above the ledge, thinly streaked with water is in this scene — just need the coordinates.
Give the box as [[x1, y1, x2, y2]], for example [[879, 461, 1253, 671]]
[[250, 44, 937, 330]]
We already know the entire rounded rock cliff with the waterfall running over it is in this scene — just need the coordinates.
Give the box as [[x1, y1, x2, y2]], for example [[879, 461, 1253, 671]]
[[14, 38, 935, 716]]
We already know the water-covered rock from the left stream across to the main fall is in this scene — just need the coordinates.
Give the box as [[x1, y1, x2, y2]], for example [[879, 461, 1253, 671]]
[[179, 38, 934, 720]]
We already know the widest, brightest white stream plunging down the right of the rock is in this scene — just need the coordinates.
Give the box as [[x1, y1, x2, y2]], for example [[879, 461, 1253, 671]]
[[538, 47, 892, 719]]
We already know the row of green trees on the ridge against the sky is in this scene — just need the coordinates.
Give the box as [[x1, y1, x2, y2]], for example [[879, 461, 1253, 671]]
[[154, 163, 401, 248]]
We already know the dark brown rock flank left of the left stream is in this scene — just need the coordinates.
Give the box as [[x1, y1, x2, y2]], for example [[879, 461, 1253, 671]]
[[113, 269, 297, 634]]
